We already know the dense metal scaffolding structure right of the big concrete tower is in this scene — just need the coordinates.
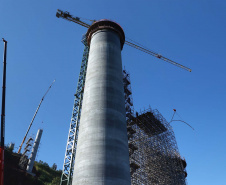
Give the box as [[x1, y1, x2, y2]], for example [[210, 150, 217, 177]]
[[123, 70, 187, 185]]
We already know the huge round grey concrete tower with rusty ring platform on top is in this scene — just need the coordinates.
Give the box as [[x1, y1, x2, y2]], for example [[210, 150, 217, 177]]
[[72, 20, 131, 185]]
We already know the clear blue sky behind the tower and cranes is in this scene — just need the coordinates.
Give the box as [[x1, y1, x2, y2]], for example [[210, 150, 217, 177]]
[[0, 0, 226, 185]]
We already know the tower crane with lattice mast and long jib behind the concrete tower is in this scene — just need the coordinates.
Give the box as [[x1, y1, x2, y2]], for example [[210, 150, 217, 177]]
[[56, 9, 191, 185]]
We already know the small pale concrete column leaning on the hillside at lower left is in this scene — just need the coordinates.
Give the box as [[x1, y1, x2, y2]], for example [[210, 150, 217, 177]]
[[27, 129, 43, 173]]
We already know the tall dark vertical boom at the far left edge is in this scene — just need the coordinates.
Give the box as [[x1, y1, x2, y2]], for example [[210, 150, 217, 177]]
[[0, 39, 7, 185]]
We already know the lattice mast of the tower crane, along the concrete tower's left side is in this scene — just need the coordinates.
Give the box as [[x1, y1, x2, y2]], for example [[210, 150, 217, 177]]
[[60, 36, 89, 185]]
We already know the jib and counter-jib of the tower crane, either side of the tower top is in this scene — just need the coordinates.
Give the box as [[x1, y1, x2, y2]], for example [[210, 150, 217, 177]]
[[56, 9, 191, 72]]
